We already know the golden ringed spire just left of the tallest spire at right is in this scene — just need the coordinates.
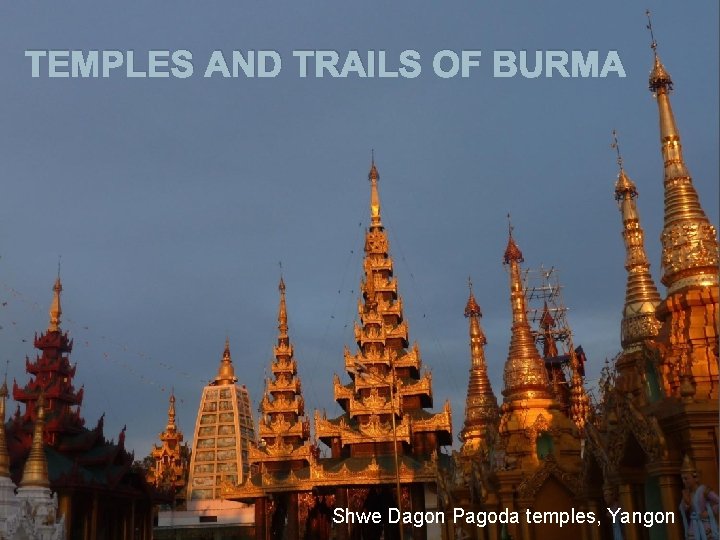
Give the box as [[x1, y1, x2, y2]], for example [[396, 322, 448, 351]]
[[612, 130, 660, 351]]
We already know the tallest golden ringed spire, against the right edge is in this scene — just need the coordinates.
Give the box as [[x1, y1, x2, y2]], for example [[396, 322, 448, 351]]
[[646, 11, 719, 294]]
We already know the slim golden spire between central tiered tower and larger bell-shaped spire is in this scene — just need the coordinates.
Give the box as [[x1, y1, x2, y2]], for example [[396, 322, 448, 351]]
[[460, 278, 499, 444]]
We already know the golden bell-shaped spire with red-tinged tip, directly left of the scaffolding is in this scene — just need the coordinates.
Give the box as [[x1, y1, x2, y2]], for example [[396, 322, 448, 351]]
[[503, 221, 550, 401]]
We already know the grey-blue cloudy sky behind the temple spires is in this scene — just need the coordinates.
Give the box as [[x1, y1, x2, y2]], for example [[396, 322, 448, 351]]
[[0, 0, 719, 457]]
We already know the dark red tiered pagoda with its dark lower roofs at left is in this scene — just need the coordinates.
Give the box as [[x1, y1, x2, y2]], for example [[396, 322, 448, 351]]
[[5, 277, 156, 540]]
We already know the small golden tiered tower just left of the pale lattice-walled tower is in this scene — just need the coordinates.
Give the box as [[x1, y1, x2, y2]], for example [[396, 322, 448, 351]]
[[147, 392, 190, 506]]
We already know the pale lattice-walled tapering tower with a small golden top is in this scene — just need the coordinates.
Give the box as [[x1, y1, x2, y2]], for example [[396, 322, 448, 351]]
[[187, 340, 255, 504]]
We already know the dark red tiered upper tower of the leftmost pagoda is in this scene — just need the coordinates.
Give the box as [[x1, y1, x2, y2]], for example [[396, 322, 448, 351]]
[[13, 276, 85, 446]]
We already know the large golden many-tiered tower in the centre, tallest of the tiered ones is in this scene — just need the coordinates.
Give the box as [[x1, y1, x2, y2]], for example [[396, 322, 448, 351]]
[[315, 162, 452, 538]]
